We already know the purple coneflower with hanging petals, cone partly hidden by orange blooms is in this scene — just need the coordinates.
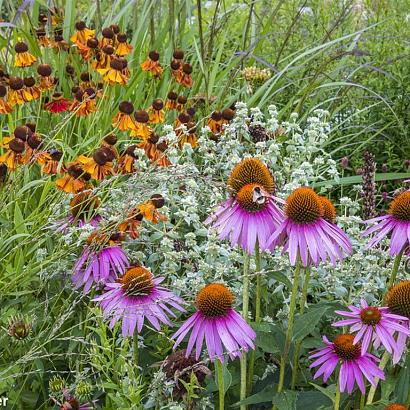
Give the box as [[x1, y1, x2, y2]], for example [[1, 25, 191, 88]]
[[72, 231, 128, 293]]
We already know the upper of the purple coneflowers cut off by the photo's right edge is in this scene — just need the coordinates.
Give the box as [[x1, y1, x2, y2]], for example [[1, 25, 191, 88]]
[[362, 191, 410, 256]]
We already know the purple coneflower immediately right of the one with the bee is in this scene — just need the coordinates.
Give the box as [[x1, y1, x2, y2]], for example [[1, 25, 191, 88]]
[[268, 187, 352, 267]]
